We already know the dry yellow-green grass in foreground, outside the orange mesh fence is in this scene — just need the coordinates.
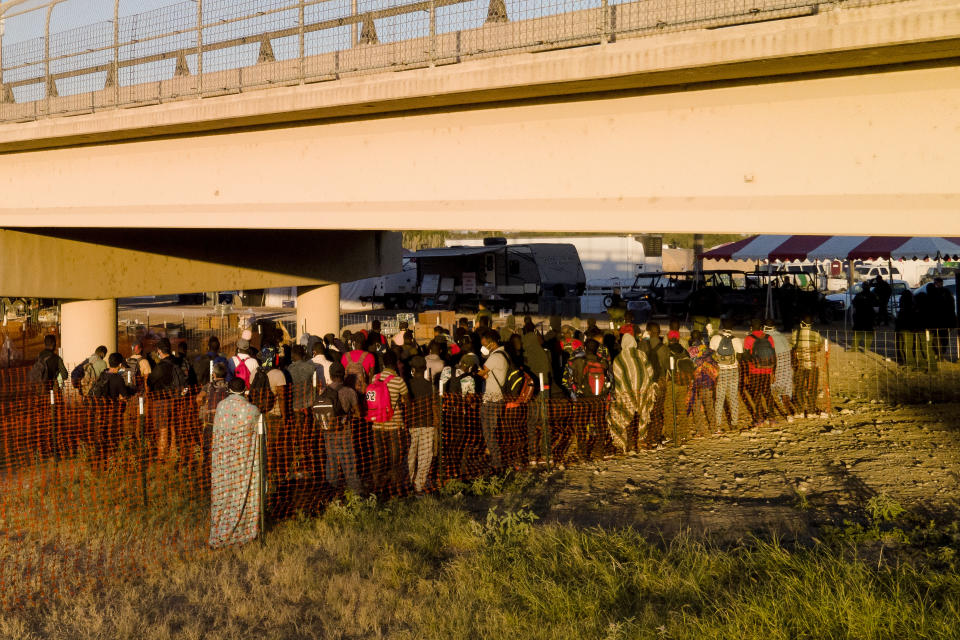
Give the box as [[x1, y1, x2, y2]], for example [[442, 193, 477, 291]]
[[0, 484, 960, 640]]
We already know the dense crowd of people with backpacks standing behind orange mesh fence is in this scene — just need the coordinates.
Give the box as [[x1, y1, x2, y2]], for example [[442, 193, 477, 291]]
[[30, 304, 822, 492]]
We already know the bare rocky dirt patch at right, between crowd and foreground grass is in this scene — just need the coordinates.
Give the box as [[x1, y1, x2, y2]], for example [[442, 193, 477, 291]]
[[484, 399, 960, 543]]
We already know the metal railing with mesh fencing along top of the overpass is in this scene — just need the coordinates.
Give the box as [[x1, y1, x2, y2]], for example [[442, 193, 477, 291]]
[[0, 0, 908, 122]]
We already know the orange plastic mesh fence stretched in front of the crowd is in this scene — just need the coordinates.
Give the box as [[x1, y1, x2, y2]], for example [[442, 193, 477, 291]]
[[0, 334, 957, 607]]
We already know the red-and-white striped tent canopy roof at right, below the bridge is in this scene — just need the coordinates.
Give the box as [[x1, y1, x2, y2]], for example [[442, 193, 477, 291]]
[[703, 235, 960, 262]]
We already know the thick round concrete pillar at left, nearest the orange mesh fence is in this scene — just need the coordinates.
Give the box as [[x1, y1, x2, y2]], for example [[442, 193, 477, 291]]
[[60, 300, 117, 367]]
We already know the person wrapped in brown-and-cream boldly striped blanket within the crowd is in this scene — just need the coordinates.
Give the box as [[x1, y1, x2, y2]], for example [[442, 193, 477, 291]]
[[607, 333, 657, 451]]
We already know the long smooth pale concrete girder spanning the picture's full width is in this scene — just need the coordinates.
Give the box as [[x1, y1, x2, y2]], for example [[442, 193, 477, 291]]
[[0, 64, 960, 235]]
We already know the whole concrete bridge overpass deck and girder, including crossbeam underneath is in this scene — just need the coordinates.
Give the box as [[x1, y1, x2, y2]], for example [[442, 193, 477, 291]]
[[0, 0, 960, 362]]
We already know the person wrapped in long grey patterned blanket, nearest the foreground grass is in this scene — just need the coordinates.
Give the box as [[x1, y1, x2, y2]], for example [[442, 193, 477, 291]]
[[210, 378, 262, 549]]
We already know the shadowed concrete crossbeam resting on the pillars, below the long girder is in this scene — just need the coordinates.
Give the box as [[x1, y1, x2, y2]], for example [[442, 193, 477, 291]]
[[0, 230, 401, 299]]
